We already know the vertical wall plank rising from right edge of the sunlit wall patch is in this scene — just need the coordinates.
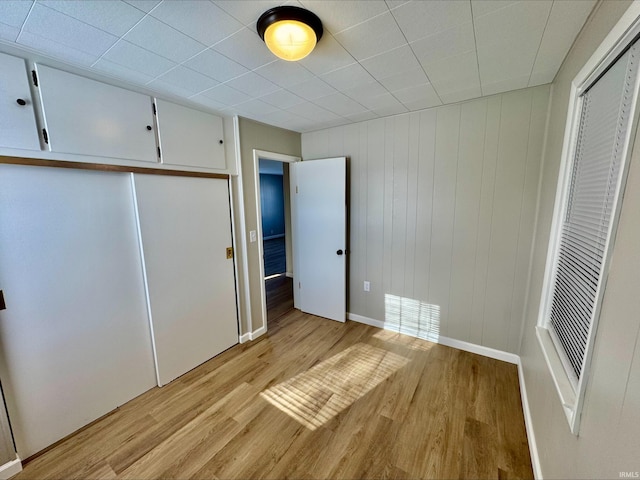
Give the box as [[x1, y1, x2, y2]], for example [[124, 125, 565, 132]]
[[428, 105, 462, 336]]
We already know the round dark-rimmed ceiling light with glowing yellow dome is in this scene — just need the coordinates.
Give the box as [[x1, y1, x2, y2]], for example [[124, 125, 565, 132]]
[[256, 5, 323, 62]]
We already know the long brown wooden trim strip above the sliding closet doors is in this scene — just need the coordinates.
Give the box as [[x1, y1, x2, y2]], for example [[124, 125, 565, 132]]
[[0, 155, 229, 180]]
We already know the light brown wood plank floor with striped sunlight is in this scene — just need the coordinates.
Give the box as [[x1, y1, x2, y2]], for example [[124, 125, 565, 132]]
[[14, 310, 533, 480]]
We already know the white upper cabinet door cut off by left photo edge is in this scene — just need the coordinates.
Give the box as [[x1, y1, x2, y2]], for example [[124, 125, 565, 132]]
[[0, 53, 40, 150]]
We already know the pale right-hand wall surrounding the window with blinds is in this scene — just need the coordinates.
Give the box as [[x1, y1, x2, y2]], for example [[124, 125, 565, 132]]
[[520, 1, 640, 478]]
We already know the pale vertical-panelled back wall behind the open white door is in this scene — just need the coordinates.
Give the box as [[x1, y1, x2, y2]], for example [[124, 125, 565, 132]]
[[302, 86, 549, 353]]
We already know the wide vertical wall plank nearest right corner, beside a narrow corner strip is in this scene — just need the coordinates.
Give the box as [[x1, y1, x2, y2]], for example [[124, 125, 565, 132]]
[[482, 90, 532, 350]]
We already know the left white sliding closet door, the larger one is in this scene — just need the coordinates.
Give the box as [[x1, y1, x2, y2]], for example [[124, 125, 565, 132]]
[[0, 165, 155, 458]]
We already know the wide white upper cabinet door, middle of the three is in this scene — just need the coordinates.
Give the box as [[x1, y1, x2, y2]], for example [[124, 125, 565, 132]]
[[38, 65, 158, 162]]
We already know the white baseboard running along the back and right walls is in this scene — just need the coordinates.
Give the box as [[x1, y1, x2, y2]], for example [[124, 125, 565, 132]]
[[347, 313, 542, 480]]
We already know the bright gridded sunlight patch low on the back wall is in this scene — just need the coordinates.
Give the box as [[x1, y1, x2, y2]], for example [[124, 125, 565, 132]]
[[384, 293, 440, 342]]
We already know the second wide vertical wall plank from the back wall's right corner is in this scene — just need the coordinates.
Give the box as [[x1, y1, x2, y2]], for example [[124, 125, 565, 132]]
[[448, 101, 487, 338]]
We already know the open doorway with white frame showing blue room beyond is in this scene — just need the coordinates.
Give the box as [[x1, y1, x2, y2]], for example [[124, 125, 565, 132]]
[[254, 150, 299, 329]]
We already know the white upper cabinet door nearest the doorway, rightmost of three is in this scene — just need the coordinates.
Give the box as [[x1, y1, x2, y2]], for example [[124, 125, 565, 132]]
[[156, 100, 226, 170]]
